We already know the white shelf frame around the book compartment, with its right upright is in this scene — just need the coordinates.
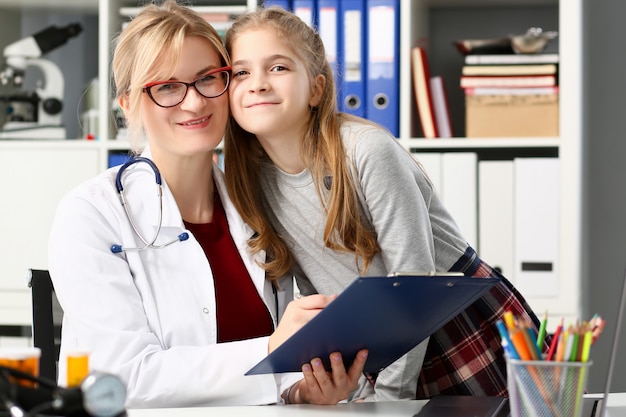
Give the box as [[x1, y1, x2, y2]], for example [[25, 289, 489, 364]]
[[399, 0, 583, 325]]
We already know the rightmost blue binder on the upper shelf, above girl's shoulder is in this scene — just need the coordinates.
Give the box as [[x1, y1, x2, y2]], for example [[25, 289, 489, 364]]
[[366, 0, 398, 137]]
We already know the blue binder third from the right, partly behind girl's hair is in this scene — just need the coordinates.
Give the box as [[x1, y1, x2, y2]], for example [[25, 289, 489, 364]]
[[315, 0, 341, 95]]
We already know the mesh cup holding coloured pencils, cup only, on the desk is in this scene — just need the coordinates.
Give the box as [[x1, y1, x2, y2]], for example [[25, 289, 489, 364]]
[[507, 358, 592, 417]]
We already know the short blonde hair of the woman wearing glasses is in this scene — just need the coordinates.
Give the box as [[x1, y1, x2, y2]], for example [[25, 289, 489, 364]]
[[112, 0, 230, 152]]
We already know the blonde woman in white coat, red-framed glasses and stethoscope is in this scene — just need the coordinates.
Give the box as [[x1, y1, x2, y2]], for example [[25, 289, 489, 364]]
[[49, 0, 367, 408]]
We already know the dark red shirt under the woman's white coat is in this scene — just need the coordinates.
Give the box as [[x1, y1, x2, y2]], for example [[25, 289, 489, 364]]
[[185, 193, 274, 343]]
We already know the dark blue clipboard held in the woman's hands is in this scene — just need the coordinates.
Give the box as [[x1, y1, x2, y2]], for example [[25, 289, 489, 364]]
[[246, 275, 501, 375]]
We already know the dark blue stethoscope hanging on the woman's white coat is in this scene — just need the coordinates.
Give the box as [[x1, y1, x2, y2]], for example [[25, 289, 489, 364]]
[[111, 156, 189, 253]]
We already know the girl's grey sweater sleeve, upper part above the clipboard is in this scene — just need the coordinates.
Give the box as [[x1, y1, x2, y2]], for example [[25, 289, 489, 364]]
[[353, 130, 435, 273]]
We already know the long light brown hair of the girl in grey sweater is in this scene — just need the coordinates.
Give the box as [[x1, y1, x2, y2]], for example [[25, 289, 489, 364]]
[[224, 7, 380, 279]]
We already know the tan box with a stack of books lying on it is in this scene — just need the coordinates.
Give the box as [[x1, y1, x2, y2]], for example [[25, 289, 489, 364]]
[[460, 54, 559, 137]]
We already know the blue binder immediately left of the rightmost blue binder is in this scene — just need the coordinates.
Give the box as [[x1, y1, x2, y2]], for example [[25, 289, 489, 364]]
[[337, 0, 367, 117]]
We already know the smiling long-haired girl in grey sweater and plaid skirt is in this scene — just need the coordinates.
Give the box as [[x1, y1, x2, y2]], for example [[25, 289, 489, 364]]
[[225, 8, 538, 400]]
